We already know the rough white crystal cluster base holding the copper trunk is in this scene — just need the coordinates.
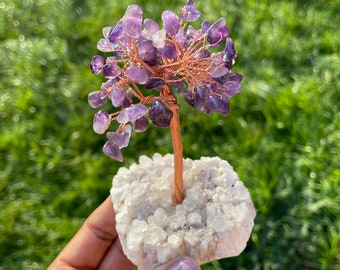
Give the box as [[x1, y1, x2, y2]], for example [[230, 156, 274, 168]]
[[111, 154, 255, 270]]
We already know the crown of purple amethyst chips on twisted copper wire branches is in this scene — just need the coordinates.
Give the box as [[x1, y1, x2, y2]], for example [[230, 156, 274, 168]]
[[88, 0, 242, 161]]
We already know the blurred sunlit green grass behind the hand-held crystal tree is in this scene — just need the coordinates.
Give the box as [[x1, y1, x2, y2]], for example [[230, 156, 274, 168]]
[[0, 0, 340, 270]]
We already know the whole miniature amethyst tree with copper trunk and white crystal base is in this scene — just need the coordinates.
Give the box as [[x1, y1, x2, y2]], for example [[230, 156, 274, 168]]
[[88, 0, 255, 269]]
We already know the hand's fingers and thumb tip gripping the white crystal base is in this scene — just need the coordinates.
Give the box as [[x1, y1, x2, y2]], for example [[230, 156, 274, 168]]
[[48, 197, 200, 270]]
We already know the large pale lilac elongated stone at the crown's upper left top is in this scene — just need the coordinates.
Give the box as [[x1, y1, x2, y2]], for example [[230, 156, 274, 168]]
[[121, 4, 143, 38]]
